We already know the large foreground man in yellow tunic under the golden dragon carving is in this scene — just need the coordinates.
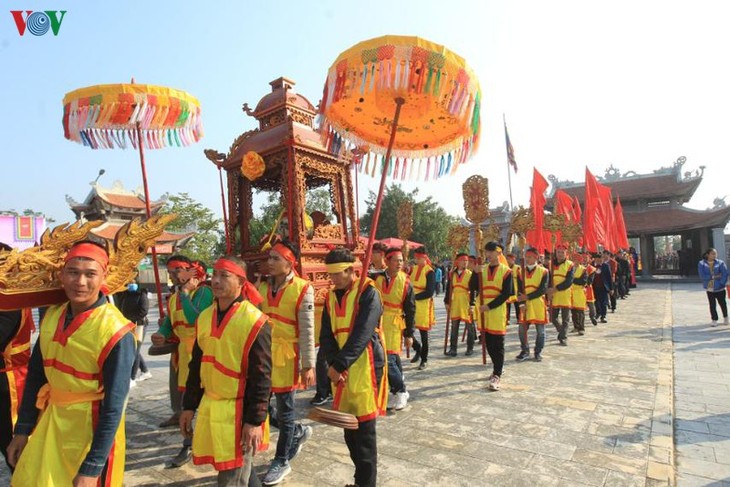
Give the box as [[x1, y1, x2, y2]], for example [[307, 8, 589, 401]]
[[8, 241, 136, 487]]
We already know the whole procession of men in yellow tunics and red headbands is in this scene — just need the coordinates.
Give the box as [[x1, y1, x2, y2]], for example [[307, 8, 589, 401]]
[[1, 234, 630, 486]]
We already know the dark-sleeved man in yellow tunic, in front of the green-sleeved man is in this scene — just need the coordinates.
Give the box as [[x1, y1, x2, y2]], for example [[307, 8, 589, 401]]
[[180, 256, 272, 486]]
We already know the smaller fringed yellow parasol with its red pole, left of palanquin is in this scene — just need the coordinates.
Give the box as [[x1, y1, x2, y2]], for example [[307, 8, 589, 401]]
[[63, 80, 203, 316]]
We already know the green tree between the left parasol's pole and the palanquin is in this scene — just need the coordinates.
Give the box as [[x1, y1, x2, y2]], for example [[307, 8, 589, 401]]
[[160, 193, 219, 263]]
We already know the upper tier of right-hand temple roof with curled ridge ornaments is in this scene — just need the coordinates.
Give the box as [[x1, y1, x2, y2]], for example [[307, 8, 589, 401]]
[[548, 157, 704, 203]]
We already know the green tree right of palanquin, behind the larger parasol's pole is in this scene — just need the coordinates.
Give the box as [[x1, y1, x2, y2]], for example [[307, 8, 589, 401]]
[[360, 183, 458, 260]]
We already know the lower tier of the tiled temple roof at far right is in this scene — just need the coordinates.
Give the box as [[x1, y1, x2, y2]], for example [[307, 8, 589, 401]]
[[624, 206, 730, 237]]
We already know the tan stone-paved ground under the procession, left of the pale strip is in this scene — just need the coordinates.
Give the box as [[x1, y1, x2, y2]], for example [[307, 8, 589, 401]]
[[0, 283, 716, 486]]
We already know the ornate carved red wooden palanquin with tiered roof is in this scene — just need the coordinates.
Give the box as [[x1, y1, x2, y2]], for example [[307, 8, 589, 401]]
[[205, 78, 364, 302]]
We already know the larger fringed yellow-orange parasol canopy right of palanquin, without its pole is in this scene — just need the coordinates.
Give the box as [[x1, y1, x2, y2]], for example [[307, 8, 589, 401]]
[[320, 36, 481, 179]]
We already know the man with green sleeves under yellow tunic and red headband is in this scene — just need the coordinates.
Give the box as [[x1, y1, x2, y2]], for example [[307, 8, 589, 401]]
[[151, 255, 213, 468]]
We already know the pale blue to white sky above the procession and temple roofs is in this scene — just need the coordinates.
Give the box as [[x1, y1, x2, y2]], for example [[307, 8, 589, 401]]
[[0, 0, 730, 222]]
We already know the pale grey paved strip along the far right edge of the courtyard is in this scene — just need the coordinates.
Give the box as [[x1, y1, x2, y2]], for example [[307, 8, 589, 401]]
[[672, 284, 730, 486]]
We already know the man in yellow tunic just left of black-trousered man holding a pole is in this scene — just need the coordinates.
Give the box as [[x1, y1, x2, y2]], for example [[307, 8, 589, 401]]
[[444, 253, 476, 357]]
